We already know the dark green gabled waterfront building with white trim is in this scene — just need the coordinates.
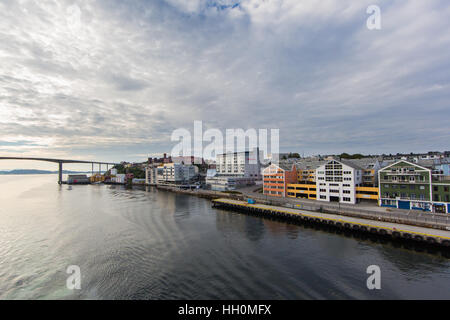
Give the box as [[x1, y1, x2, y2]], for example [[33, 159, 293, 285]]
[[378, 160, 450, 213]]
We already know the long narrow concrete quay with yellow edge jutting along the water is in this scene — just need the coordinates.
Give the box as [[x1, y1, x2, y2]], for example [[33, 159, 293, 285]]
[[212, 199, 450, 247]]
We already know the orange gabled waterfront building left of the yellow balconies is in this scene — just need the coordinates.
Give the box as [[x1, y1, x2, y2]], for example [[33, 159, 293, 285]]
[[263, 164, 297, 197]]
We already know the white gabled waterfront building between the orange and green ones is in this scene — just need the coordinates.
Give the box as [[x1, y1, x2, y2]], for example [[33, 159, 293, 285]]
[[316, 160, 363, 204]]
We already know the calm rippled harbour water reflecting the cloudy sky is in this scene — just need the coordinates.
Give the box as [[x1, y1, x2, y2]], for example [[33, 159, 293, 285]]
[[0, 175, 450, 299]]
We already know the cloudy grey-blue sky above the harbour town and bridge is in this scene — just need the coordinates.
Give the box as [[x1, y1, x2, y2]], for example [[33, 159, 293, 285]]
[[0, 0, 450, 170]]
